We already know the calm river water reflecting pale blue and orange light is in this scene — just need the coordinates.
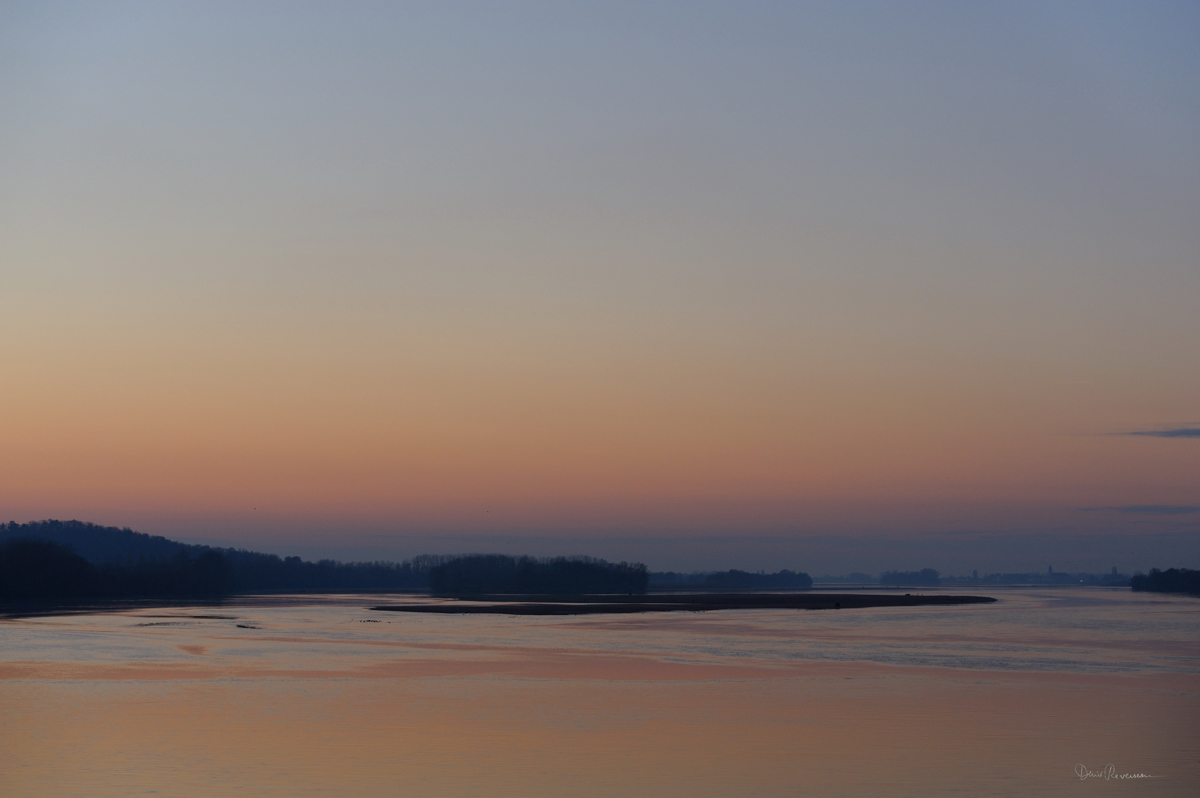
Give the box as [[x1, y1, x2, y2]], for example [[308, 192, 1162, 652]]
[[0, 589, 1200, 798]]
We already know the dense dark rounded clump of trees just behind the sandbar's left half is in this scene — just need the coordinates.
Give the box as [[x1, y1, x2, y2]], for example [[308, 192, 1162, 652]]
[[430, 554, 649, 595]]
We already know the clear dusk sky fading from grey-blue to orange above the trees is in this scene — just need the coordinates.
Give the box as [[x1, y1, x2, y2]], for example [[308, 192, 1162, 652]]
[[0, 2, 1200, 572]]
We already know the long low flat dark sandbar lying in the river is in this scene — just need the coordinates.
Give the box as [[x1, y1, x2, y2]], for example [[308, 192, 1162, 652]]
[[371, 593, 996, 616]]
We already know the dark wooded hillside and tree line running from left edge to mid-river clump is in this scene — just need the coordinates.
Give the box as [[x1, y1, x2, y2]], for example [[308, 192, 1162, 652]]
[[0, 521, 648, 601]]
